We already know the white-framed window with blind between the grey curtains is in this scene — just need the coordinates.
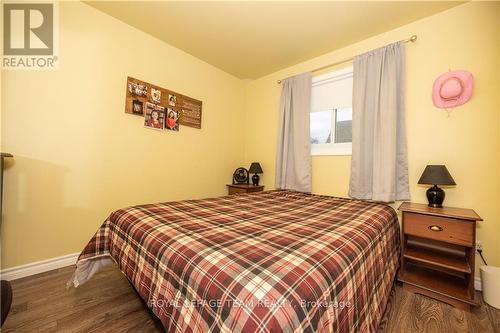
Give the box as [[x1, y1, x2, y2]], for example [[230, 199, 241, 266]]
[[311, 67, 352, 155]]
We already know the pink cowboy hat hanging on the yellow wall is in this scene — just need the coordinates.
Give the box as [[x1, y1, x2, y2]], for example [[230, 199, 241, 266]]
[[432, 71, 474, 109]]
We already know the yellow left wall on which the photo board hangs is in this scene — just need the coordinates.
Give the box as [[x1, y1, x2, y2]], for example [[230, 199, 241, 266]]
[[1, 2, 244, 268]]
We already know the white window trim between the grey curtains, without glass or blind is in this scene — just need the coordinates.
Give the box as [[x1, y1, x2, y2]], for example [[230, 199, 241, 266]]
[[311, 66, 353, 156]]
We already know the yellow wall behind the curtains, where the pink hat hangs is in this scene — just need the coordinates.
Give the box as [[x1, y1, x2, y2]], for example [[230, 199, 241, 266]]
[[245, 3, 500, 265]]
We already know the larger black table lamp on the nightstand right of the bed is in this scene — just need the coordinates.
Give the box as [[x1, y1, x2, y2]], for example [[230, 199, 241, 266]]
[[418, 165, 457, 207]]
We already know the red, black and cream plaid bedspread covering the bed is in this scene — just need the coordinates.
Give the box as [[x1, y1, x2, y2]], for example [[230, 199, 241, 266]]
[[78, 191, 399, 332]]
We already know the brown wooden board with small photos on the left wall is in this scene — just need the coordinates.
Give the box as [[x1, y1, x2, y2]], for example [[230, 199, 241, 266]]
[[125, 76, 202, 130]]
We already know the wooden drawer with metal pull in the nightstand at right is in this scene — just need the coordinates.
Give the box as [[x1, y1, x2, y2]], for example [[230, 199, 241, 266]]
[[403, 212, 474, 247]]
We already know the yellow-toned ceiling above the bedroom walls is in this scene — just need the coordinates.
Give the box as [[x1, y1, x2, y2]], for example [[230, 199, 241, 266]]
[[86, 1, 462, 79]]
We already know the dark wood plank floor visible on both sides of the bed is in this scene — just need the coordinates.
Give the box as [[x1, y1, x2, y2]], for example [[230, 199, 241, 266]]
[[1, 266, 500, 333]]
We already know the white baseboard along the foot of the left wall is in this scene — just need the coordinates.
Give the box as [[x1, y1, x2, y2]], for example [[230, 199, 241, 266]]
[[0, 252, 80, 281]]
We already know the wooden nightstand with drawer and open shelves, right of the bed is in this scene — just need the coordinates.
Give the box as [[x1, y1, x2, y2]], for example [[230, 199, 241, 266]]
[[398, 202, 482, 311]]
